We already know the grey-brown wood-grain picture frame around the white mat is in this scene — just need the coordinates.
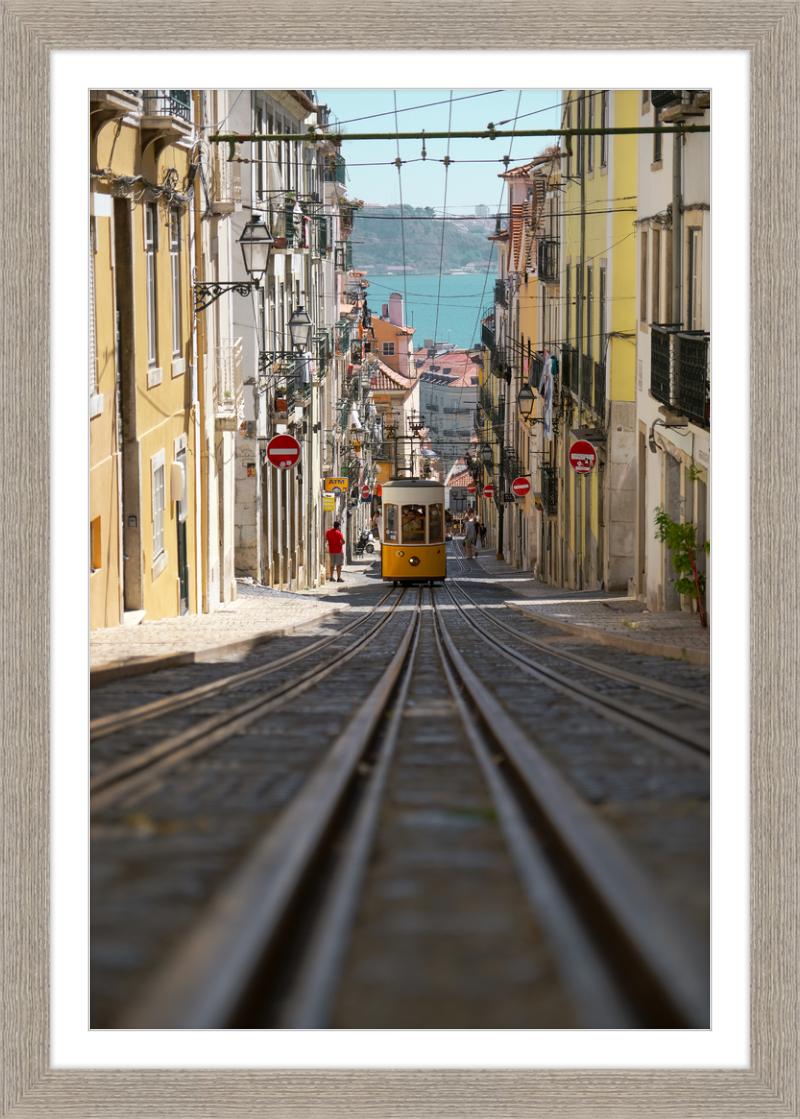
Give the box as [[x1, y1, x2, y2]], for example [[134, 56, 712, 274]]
[[0, 0, 800, 1119]]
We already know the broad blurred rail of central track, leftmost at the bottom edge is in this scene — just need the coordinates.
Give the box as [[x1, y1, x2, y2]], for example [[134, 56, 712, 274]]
[[116, 594, 421, 1029]]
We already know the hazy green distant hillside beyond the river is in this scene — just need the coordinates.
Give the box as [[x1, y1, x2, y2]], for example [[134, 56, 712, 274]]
[[350, 206, 495, 272]]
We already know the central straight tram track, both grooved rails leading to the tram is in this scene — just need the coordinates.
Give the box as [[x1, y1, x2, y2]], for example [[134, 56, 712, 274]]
[[111, 591, 708, 1028]]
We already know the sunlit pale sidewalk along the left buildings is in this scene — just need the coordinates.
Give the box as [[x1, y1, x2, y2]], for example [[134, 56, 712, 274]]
[[90, 555, 380, 687]]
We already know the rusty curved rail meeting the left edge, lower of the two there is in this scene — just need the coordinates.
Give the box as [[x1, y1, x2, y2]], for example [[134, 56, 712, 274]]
[[90, 589, 405, 814]]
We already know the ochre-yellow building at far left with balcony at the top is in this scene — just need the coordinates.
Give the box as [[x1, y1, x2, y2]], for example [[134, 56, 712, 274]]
[[90, 90, 197, 628]]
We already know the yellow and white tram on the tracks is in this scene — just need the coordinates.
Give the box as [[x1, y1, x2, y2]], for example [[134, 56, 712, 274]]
[[380, 478, 448, 584]]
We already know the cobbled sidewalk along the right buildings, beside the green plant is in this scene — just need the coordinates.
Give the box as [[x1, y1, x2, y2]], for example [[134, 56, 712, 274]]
[[476, 548, 710, 665]]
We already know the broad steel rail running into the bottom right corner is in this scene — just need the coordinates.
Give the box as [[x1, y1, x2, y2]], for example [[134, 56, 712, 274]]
[[429, 590, 709, 1028]]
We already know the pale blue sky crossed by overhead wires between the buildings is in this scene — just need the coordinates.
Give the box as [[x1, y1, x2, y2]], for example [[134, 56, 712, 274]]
[[317, 88, 561, 215]]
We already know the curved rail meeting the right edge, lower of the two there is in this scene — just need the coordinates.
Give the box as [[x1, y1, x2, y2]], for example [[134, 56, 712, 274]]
[[445, 586, 710, 770]]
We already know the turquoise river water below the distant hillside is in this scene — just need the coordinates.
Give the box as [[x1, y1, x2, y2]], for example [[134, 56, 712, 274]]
[[367, 266, 497, 350]]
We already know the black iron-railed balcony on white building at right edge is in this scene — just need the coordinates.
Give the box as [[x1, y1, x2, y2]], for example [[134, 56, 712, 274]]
[[650, 322, 710, 427]]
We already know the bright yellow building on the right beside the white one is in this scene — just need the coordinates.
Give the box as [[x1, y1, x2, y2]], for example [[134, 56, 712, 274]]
[[556, 90, 639, 591]]
